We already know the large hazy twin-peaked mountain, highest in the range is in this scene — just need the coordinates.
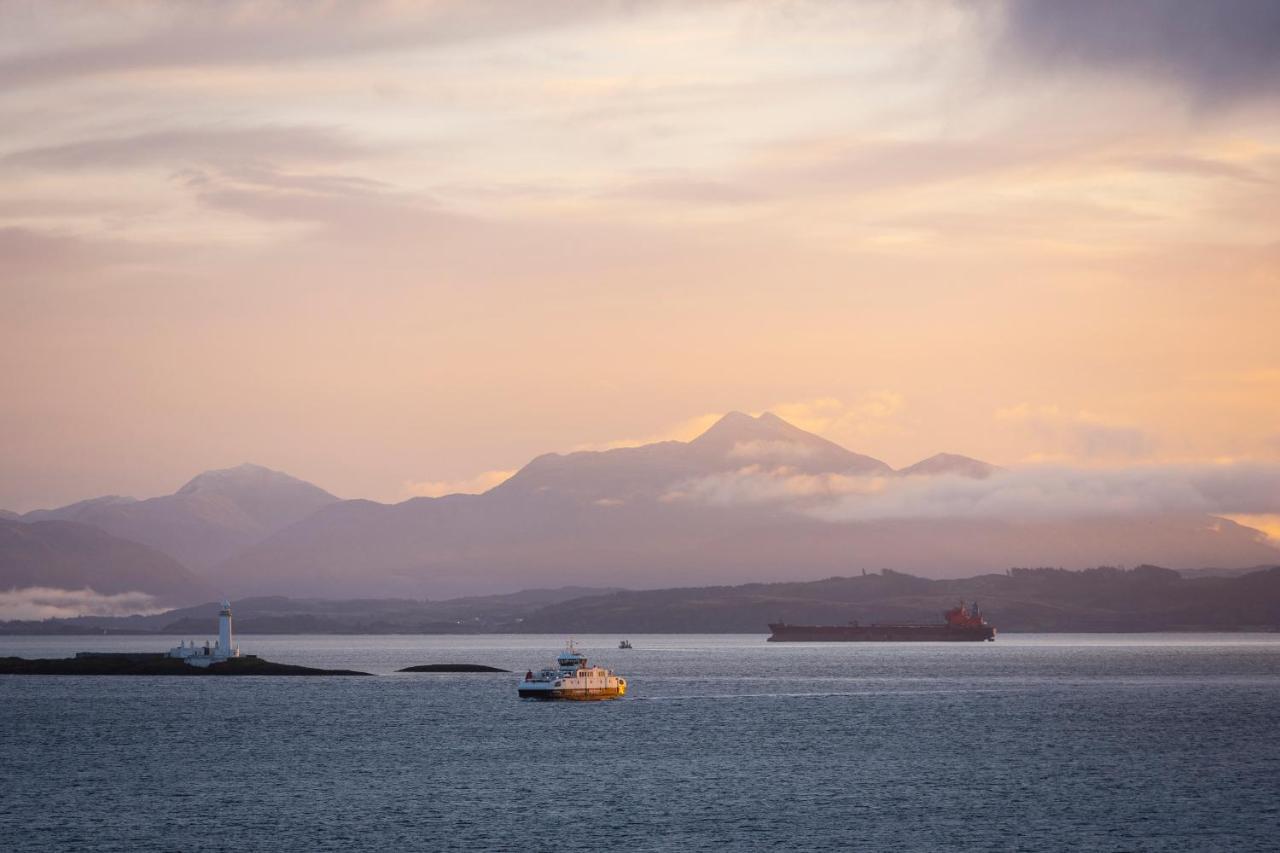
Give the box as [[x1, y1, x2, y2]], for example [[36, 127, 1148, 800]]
[[216, 412, 1277, 598]]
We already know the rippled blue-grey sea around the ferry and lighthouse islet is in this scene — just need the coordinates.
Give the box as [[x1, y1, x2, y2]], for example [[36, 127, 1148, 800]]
[[0, 634, 1280, 853]]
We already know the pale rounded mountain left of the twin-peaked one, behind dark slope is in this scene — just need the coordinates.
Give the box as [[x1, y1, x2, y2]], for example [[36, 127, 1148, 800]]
[[22, 465, 338, 569]]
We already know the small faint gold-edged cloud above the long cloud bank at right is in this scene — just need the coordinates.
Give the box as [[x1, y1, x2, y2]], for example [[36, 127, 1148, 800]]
[[996, 403, 1156, 460]]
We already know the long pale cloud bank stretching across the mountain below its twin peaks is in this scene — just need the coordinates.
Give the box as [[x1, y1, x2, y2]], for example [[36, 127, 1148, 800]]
[[664, 464, 1280, 521]]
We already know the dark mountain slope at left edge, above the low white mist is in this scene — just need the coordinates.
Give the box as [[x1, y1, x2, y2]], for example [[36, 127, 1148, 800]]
[[0, 520, 210, 603]]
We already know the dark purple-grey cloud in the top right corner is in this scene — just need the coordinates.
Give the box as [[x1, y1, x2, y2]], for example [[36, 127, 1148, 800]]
[[1004, 0, 1280, 105]]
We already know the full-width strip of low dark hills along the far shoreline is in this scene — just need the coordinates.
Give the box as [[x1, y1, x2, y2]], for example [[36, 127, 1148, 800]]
[[12, 566, 1280, 637]]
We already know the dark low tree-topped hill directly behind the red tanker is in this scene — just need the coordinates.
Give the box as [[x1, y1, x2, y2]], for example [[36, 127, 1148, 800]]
[[521, 566, 1280, 633]]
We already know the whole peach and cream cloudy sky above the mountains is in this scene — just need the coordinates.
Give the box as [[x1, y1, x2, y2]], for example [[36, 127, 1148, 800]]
[[0, 0, 1280, 512]]
